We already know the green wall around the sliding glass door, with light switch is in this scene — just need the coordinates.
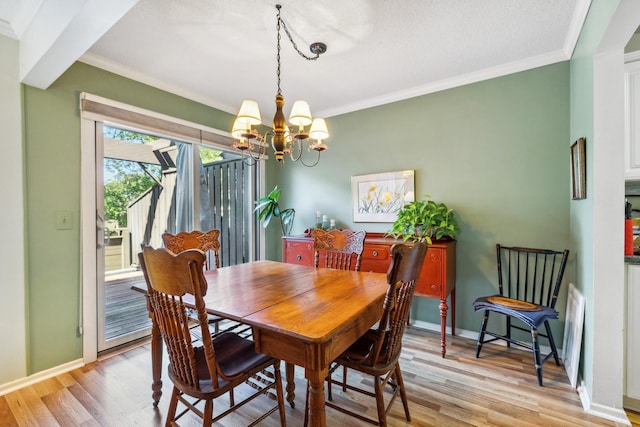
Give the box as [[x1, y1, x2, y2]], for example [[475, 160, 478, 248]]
[[23, 63, 233, 373]]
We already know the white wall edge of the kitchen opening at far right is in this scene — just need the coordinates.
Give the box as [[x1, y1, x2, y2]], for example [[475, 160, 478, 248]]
[[590, 0, 640, 413]]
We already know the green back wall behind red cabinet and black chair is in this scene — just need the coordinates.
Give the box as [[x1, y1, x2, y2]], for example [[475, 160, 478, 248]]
[[278, 62, 573, 336]]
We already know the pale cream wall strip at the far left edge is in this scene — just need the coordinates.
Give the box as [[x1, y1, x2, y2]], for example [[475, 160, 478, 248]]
[[0, 36, 27, 384]]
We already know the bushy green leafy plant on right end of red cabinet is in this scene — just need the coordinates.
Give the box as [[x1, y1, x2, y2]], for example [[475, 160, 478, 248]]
[[387, 195, 460, 244]]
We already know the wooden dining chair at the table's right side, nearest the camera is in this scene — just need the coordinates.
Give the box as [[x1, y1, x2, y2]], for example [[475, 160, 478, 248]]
[[304, 241, 427, 426]]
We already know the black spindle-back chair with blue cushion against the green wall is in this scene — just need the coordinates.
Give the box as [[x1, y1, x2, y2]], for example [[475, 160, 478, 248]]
[[473, 244, 569, 386]]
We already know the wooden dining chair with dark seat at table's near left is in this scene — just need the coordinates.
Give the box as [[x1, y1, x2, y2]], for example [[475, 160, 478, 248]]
[[140, 247, 286, 426]]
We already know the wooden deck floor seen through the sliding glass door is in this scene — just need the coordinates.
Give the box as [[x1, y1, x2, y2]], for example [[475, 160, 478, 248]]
[[105, 271, 151, 340]]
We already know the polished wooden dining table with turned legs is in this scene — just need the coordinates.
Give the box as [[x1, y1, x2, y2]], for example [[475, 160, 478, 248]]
[[140, 261, 387, 426]]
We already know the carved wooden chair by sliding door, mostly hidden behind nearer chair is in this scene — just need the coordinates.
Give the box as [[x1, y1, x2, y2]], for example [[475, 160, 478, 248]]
[[162, 229, 246, 339]]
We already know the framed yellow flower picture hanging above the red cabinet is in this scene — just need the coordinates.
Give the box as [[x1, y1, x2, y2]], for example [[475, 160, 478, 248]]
[[351, 170, 415, 222]]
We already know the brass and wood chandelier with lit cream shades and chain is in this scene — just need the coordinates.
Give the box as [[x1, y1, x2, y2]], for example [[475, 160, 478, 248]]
[[231, 4, 329, 167]]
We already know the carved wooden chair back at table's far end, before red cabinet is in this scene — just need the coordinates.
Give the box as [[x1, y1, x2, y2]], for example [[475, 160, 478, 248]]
[[311, 228, 367, 271]]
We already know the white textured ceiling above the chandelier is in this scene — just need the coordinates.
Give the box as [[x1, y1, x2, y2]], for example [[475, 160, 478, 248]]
[[0, 0, 590, 127]]
